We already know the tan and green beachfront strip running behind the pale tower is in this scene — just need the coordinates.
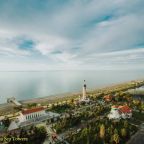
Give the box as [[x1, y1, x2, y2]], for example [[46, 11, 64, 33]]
[[0, 80, 144, 116]]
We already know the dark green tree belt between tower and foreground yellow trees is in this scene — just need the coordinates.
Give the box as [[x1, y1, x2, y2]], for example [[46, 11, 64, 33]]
[[53, 105, 108, 133]]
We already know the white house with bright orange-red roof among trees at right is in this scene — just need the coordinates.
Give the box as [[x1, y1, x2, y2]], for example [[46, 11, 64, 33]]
[[108, 105, 132, 119]]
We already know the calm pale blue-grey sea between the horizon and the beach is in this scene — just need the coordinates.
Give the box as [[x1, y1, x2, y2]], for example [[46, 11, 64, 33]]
[[0, 71, 144, 103]]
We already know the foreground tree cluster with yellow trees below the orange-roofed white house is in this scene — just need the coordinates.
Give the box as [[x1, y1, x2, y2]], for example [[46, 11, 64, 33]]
[[67, 119, 137, 144]]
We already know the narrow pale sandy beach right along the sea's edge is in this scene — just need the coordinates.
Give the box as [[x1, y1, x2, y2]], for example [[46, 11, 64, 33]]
[[0, 80, 144, 109]]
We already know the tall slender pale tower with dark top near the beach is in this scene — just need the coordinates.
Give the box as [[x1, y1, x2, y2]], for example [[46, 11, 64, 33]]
[[79, 80, 90, 103]]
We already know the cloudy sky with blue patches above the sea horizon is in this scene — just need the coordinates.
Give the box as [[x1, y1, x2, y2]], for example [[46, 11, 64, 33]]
[[0, 0, 144, 71]]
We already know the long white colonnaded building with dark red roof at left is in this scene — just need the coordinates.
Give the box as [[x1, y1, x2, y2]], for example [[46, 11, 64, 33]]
[[8, 107, 60, 131]]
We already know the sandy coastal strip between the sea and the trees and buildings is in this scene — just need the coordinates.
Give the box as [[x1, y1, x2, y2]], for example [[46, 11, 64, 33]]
[[0, 79, 144, 115]]
